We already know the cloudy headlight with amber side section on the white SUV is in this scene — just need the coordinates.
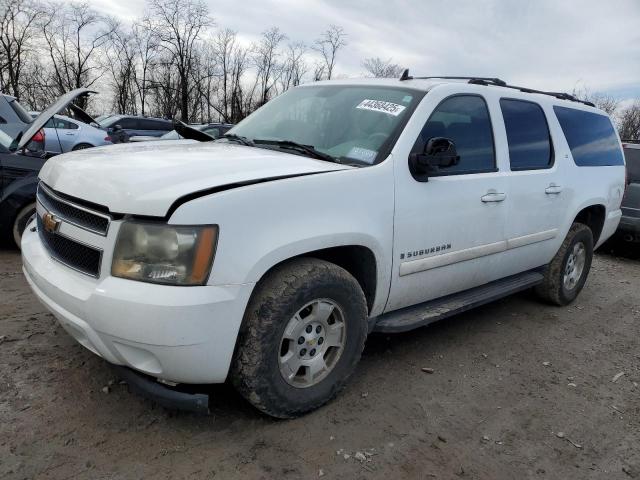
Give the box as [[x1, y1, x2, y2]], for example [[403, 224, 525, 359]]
[[111, 222, 218, 285]]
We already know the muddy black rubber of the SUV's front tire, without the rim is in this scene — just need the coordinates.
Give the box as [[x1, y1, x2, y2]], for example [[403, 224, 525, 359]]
[[231, 258, 367, 418]]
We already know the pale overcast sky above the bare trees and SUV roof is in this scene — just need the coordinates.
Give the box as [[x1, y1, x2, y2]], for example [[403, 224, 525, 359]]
[[91, 0, 640, 106]]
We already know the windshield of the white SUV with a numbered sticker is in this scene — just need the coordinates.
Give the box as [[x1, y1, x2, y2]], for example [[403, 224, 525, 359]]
[[228, 85, 424, 165]]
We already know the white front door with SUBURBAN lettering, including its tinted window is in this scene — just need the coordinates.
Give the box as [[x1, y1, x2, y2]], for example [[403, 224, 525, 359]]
[[387, 91, 508, 311]]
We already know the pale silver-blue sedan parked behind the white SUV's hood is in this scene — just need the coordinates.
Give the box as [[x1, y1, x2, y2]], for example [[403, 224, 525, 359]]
[[29, 112, 113, 153]]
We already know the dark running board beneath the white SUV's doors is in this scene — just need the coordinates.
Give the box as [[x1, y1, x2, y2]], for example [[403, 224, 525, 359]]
[[369, 271, 543, 333]]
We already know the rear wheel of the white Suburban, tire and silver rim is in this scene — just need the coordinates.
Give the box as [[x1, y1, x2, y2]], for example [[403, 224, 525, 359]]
[[535, 223, 593, 306]]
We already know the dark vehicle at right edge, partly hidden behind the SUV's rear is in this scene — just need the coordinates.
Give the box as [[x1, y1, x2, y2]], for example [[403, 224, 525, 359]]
[[616, 143, 640, 243]]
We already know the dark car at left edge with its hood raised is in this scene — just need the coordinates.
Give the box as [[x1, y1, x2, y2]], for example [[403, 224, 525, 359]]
[[0, 88, 96, 247]]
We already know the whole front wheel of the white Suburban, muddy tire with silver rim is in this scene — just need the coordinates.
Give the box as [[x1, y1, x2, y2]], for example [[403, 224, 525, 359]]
[[230, 258, 367, 418]]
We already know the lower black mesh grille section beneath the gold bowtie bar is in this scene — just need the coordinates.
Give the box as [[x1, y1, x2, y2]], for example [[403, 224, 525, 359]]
[[37, 215, 102, 277]]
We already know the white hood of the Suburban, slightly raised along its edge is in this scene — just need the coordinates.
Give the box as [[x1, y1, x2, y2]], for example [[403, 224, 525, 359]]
[[40, 140, 355, 217]]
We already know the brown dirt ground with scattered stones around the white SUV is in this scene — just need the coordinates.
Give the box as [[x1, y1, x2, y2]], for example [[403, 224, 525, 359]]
[[0, 249, 640, 480]]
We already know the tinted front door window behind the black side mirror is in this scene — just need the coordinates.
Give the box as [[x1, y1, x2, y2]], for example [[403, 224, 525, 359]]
[[412, 95, 496, 175]]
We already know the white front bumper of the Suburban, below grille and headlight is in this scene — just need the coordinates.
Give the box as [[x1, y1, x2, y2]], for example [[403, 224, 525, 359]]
[[22, 223, 254, 384]]
